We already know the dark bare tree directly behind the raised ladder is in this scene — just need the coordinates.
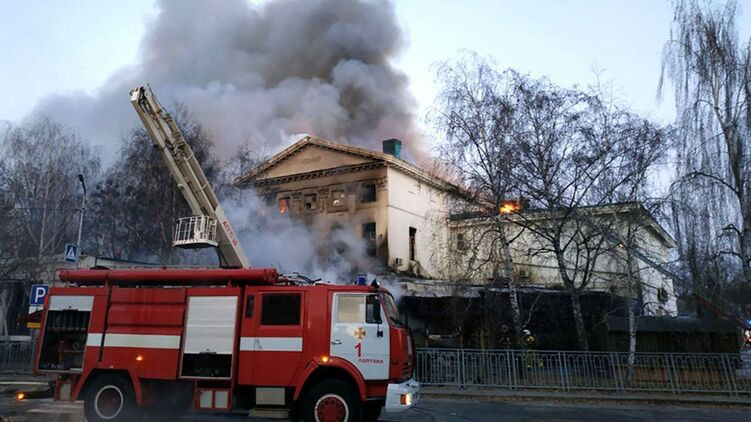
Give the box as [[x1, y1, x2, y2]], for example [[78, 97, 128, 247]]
[[92, 104, 225, 264]]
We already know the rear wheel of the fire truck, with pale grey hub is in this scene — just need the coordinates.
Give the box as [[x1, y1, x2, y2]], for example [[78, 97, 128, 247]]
[[83, 375, 137, 422]]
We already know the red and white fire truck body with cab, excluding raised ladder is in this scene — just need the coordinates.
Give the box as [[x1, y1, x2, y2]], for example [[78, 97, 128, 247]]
[[36, 268, 419, 421]]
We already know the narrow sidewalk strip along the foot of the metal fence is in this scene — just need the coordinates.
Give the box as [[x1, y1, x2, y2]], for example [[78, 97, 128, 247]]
[[421, 386, 751, 407]]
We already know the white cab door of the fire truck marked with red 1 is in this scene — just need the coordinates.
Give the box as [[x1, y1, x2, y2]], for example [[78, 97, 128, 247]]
[[330, 293, 389, 380]]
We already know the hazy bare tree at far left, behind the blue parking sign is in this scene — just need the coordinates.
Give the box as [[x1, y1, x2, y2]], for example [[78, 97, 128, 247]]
[[0, 116, 100, 333]]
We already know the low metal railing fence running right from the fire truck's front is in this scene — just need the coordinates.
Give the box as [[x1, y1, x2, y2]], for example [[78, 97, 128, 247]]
[[415, 349, 751, 396]]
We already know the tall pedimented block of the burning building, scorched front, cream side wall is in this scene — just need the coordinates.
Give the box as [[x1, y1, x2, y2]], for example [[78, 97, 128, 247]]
[[236, 136, 455, 279]]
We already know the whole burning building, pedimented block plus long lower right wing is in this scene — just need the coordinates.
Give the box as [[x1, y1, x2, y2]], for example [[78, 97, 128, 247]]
[[235, 136, 677, 315]]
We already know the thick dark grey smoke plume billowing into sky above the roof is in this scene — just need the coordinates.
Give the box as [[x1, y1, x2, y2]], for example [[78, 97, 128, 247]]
[[38, 0, 422, 159]]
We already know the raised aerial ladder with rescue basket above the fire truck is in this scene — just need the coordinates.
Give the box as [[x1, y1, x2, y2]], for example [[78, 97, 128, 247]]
[[130, 85, 250, 268]]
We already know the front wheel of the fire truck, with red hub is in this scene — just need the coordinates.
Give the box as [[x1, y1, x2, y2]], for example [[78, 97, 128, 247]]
[[301, 379, 362, 422]]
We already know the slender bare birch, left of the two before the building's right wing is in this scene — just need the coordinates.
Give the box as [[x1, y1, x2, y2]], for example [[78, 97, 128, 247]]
[[434, 54, 522, 346]]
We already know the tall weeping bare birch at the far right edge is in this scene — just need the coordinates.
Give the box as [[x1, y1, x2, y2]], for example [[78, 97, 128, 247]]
[[660, 0, 751, 312]]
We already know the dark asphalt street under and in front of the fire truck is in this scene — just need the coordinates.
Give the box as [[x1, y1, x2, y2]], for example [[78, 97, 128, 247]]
[[0, 396, 751, 422]]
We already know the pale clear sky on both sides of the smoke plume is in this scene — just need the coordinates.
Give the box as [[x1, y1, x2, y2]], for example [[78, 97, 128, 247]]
[[0, 0, 751, 150]]
